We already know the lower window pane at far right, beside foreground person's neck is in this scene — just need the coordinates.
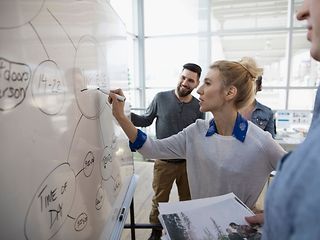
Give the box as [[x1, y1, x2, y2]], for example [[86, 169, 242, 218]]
[[288, 89, 316, 110]]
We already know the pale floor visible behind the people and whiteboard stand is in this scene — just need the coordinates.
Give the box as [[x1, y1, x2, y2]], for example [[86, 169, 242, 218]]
[[121, 160, 266, 240]]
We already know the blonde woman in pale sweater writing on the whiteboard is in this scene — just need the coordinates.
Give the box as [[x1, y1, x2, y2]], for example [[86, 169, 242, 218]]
[[110, 58, 285, 208]]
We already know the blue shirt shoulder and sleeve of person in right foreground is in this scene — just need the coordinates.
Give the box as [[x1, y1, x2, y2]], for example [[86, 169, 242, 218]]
[[265, 121, 320, 239]]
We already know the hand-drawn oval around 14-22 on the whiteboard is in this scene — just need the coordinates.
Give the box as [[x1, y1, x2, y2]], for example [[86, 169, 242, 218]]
[[31, 60, 66, 115]]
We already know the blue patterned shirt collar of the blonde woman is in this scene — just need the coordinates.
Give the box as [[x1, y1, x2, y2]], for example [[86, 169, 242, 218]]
[[206, 113, 248, 142]]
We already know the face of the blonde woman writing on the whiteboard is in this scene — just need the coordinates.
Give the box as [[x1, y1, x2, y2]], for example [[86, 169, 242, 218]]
[[197, 69, 225, 112]]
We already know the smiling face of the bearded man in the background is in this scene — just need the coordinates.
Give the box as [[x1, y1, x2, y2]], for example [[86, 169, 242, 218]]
[[177, 69, 199, 97]]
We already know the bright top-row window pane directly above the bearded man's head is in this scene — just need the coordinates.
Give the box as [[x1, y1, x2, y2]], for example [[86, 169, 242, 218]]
[[144, 0, 202, 35]]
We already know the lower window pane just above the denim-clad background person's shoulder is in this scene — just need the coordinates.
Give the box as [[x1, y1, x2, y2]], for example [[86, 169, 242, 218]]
[[256, 88, 286, 111]]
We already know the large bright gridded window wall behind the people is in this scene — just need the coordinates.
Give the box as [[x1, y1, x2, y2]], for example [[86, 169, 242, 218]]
[[110, 0, 320, 122]]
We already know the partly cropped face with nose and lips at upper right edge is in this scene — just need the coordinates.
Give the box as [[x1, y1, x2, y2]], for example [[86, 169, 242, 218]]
[[297, 0, 320, 61]]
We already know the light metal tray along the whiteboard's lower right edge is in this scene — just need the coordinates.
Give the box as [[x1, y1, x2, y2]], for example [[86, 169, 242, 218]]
[[110, 175, 138, 240]]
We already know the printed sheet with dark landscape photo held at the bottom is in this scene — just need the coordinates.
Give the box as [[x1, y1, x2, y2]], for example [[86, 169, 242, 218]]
[[161, 198, 262, 240]]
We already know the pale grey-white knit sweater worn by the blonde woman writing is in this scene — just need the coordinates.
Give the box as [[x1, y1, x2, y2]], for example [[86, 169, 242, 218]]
[[138, 120, 286, 208]]
